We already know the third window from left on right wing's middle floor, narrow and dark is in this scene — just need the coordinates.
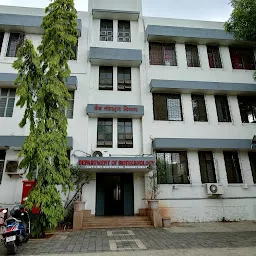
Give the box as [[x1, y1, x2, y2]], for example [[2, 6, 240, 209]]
[[215, 95, 231, 122]]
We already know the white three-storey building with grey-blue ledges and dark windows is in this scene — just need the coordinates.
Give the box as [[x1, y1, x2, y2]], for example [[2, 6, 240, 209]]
[[0, 0, 256, 221]]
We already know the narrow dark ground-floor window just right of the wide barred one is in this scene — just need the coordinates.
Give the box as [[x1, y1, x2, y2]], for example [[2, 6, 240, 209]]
[[198, 151, 216, 183]]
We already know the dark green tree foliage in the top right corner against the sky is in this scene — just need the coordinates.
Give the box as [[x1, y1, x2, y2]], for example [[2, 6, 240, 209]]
[[224, 0, 256, 80]]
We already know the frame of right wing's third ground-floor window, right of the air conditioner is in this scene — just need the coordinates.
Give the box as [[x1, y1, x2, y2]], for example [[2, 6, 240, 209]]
[[223, 151, 243, 184]]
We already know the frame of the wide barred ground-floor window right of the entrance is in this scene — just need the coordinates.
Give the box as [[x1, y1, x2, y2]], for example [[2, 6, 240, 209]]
[[156, 151, 190, 185]]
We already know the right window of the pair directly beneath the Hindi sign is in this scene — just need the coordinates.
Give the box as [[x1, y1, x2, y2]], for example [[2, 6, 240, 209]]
[[118, 119, 133, 148]]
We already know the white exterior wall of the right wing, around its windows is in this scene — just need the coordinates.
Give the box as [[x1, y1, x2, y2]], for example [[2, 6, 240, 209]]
[[142, 18, 256, 222]]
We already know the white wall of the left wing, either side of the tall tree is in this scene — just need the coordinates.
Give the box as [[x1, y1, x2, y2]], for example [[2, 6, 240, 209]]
[[0, 6, 89, 207]]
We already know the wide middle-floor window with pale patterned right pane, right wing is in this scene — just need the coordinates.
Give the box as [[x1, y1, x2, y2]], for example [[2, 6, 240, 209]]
[[153, 94, 183, 121]]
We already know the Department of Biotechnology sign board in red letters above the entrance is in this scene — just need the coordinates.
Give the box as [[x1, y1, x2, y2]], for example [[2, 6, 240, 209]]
[[78, 156, 156, 169]]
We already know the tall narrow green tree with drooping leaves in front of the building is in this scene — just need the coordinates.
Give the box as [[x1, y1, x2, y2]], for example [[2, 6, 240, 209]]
[[13, 0, 78, 235]]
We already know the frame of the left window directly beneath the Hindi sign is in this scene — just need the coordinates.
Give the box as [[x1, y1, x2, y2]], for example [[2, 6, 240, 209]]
[[97, 118, 113, 148]]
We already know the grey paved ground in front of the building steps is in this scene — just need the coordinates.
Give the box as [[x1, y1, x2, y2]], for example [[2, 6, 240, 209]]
[[0, 222, 256, 256]]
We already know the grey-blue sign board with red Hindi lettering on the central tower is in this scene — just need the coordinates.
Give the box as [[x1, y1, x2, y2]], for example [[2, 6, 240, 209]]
[[86, 104, 144, 118]]
